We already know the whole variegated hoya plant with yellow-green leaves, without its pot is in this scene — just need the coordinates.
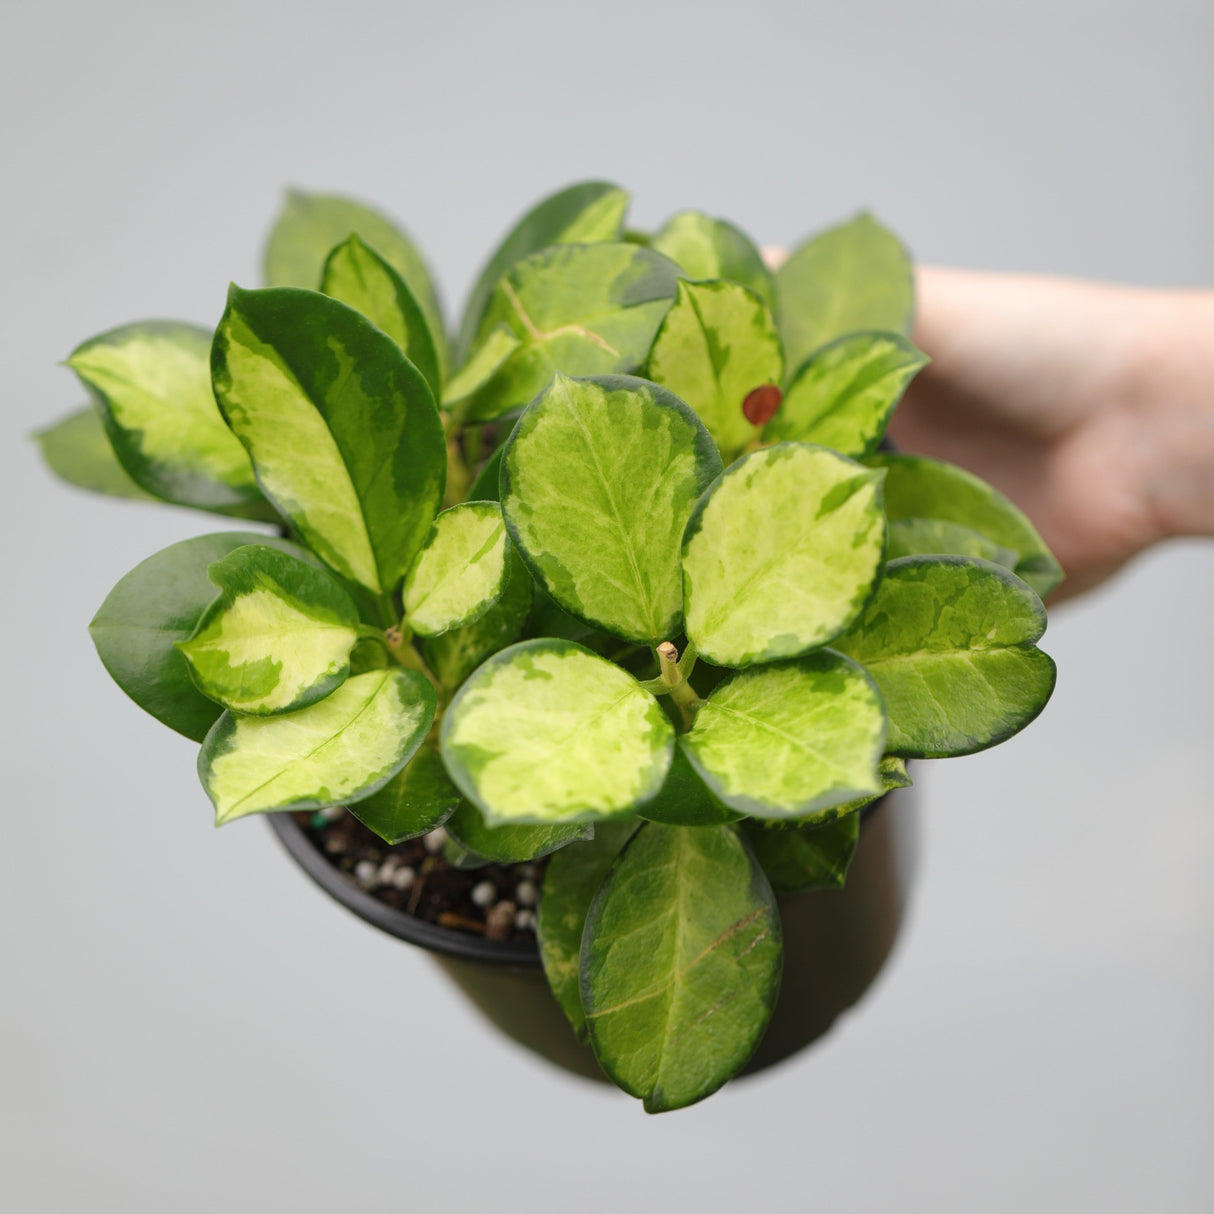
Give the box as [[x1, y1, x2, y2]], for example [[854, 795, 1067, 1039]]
[[40, 182, 1061, 1111]]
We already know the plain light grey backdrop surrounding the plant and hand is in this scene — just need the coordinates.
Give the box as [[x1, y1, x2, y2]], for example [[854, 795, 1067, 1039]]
[[0, 0, 1214, 1214]]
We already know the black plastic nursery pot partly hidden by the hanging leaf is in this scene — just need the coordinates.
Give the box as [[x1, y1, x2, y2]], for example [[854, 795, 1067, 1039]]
[[268, 788, 917, 1079]]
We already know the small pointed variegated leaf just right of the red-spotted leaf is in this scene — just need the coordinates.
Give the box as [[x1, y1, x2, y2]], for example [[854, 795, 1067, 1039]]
[[764, 333, 927, 459]]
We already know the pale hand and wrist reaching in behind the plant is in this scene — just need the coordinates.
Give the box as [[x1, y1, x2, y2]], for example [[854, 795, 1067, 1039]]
[[772, 250, 1214, 601]]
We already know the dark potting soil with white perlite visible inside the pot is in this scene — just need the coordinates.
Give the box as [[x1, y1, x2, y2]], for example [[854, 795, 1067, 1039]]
[[291, 810, 544, 940]]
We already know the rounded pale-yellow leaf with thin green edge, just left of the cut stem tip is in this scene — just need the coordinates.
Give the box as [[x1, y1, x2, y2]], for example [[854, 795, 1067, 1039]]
[[442, 640, 674, 826]]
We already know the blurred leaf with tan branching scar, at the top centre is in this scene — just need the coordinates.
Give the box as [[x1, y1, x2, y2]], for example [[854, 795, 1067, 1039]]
[[460, 243, 679, 421]]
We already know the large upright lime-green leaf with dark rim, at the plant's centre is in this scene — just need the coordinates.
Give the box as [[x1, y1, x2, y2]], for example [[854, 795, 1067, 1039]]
[[501, 375, 721, 642]]
